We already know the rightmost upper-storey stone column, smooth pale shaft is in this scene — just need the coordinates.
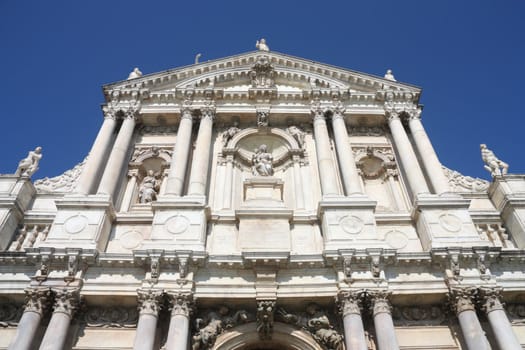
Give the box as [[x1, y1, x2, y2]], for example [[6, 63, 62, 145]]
[[408, 110, 450, 194]]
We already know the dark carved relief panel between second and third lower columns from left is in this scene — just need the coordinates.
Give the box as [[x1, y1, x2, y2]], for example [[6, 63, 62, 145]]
[[83, 306, 138, 328]]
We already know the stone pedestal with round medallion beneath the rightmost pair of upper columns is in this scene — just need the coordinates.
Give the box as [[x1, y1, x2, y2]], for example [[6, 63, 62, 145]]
[[413, 194, 487, 250]]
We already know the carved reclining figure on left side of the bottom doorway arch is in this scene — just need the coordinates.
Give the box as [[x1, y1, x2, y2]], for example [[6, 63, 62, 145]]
[[192, 306, 248, 350]]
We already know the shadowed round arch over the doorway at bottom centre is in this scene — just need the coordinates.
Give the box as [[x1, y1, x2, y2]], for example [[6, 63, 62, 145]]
[[212, 322, 323, 350]]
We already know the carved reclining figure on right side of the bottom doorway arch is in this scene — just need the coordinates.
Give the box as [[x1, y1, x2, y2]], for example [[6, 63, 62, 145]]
[[278, 303, 343, 350]]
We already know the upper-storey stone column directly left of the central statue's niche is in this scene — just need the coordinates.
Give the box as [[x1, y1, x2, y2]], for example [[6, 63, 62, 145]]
[[188, 106, 215, 196]]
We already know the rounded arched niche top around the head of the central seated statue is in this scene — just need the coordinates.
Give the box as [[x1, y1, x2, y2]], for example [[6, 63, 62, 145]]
[[227, 128, 304, 171]]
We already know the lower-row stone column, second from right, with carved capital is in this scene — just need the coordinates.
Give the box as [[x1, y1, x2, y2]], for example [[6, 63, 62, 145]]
[[451, 288, 490, 350]]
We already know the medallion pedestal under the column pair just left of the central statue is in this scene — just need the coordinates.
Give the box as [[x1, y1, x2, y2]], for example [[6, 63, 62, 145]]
[[146, 196, 209, 251]]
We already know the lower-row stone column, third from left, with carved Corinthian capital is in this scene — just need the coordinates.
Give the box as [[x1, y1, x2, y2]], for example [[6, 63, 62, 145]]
[[133, 289, 162, 350]]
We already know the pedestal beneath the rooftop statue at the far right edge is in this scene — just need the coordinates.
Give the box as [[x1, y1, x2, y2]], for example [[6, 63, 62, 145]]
[[489, 175, 525, 249]]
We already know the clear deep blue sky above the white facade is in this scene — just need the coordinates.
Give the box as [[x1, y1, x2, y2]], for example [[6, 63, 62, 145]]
[[0, 0, 525, 179]]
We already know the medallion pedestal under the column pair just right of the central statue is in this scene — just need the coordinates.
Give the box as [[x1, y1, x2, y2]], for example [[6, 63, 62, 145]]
[[318, 195, 376, 253]]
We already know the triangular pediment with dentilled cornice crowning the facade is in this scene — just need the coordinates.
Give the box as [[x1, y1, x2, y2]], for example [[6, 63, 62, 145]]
[[104, 51, 421, 100]]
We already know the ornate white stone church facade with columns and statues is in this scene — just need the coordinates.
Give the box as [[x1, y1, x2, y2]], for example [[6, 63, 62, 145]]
[[0, 40, 525, 350]]
